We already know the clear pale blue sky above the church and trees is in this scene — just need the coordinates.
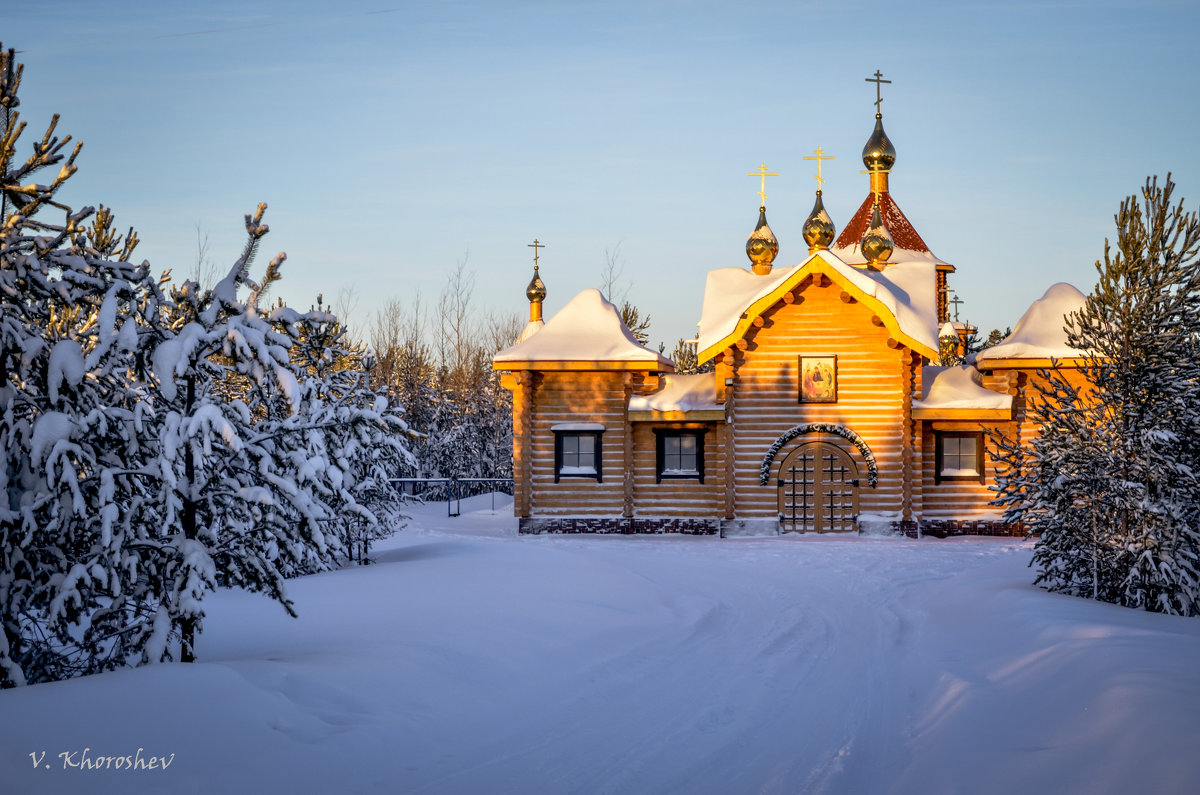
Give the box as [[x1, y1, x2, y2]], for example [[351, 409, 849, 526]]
[[0, 0, 1200, 349]]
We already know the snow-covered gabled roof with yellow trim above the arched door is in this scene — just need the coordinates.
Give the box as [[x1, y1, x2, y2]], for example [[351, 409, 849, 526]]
[[697, 251, 938, 360]]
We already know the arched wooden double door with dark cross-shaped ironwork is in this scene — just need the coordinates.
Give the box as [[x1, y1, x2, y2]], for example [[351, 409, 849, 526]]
[[779, 442, 858, 533]]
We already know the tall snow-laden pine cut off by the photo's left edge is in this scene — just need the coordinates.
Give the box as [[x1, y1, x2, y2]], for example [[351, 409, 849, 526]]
[[0, 49, 161, 686]]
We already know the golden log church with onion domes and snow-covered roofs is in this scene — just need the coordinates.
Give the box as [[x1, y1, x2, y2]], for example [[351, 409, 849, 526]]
[[493, 72, 1084, 534]]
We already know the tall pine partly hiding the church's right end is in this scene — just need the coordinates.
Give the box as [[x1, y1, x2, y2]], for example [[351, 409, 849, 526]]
[[997, 175, 1200, 616]]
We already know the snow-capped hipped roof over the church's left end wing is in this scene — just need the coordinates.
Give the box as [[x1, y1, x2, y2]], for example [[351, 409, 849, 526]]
[[492, 288, 674, 372]]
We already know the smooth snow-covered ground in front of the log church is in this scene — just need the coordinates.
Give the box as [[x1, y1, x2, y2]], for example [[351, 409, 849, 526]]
[[0, 497, 1200, 794]]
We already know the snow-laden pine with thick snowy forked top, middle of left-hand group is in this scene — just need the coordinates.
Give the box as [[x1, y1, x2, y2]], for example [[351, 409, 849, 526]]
[[136, 204, 364, 662]]
